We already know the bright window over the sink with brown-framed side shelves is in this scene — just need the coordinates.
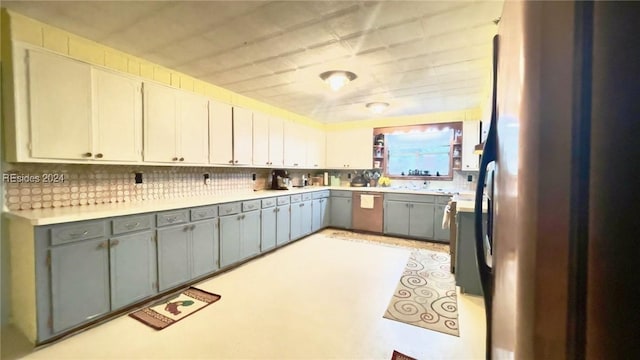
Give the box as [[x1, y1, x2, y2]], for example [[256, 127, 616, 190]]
[[373, 122, 462, 180]]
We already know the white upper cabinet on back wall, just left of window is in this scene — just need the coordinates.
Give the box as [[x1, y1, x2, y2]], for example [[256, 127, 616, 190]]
[[326, 128, 373, 169]]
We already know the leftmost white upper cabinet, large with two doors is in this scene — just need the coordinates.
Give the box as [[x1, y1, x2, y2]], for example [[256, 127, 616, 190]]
[[12, 47, 142, 163]]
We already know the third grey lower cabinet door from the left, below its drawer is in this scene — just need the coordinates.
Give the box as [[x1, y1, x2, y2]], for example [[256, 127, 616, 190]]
[[158, 225, 191, 291]]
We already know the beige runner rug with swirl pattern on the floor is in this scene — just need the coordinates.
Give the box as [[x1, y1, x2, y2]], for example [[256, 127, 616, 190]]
[[384, 250, 459, 336]]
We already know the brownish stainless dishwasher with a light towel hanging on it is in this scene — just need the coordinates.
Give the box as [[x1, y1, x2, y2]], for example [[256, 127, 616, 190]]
[[351, 191, 384, 234]]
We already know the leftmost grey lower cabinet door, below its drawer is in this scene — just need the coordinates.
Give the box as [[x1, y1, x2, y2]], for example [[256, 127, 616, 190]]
[[49, 238, 110, 333]]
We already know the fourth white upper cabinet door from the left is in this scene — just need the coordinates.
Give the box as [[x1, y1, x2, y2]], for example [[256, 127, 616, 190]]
[[176, 92, 209, 165]]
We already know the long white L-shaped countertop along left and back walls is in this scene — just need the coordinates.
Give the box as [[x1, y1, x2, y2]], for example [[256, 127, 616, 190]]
[[5, 186, 464, 226]]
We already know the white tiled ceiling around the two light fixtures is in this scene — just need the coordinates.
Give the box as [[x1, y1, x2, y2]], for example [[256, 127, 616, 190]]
[[2, 1, 503, 123]]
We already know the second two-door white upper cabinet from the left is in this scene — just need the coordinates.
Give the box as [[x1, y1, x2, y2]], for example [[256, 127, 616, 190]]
[[144, 83, 209, 164]]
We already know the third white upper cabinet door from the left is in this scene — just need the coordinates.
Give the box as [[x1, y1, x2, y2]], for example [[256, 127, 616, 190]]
[[144, 83, 178, 163]]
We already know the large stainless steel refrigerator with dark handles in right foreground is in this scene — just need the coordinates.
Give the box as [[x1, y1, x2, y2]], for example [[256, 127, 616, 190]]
[[476, 1, 640, 359]]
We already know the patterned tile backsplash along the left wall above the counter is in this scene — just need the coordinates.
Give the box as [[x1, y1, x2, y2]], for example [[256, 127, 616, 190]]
[[3, 164, 269, 210]]
